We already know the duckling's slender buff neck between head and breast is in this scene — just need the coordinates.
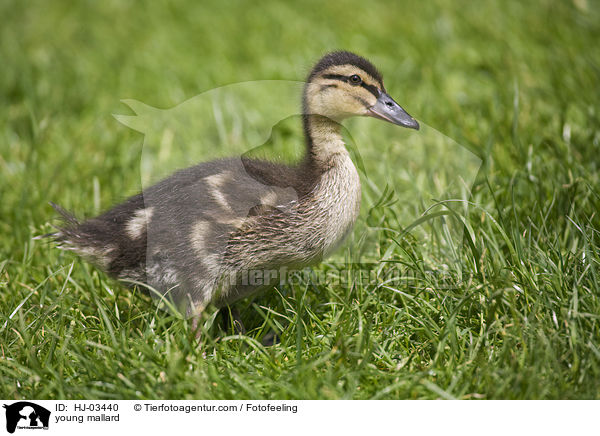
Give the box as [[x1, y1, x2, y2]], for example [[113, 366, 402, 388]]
[[303, 114, 348, 170]]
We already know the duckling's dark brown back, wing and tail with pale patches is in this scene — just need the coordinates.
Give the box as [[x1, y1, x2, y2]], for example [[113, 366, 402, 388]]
[[54, 158, 298, 310]]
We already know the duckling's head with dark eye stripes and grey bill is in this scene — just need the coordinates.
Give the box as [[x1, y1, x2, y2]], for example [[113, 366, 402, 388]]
[[304, 51, 419, 130]]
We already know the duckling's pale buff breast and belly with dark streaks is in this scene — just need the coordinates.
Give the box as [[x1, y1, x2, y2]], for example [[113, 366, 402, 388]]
[[226, 153, 361, 268]]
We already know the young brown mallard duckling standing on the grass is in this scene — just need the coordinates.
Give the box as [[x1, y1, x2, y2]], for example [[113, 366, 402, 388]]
[[52, 51, 419, 317]]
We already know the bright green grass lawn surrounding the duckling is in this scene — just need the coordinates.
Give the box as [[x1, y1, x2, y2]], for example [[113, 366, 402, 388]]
[[0, 0, 600, 399]]
